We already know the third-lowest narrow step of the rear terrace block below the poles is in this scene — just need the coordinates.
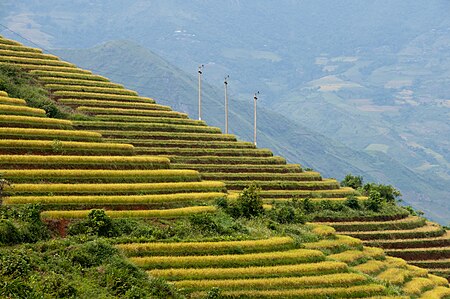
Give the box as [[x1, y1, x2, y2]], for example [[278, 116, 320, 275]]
[[201, 171, 322, 182]]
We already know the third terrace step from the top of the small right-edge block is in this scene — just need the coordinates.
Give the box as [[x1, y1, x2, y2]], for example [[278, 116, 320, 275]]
[[340, 222, 445, 241]]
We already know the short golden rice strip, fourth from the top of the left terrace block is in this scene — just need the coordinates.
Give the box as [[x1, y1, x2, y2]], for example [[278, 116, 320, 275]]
[[0, 115, 72, 128]]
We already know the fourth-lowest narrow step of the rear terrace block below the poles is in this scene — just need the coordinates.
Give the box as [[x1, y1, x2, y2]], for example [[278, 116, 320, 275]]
[[171, 163, 302, 175]]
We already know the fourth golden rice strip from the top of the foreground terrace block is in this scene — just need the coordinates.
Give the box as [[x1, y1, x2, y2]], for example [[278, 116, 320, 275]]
[[174, 273, 367, 290]]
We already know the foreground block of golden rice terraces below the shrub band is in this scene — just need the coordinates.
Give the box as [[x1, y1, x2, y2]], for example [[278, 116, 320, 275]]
[[116, 226, 448, 298]]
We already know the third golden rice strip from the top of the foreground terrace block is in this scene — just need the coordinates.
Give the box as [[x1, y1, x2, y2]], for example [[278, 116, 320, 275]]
[[148, 261, 347, 281]]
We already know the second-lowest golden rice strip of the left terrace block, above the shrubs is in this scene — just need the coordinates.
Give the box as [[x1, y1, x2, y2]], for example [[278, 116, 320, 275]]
[[3, 190, 225, 205]]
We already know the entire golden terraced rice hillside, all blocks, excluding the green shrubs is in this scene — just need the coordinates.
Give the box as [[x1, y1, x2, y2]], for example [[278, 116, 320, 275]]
[[0, 37, 450, 298]]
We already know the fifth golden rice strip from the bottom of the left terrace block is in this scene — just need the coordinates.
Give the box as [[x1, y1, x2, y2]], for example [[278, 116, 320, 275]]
[[0, 156, 170, 169]]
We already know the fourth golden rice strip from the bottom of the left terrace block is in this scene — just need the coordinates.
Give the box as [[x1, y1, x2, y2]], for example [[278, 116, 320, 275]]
[[0, 169, 200, 183]]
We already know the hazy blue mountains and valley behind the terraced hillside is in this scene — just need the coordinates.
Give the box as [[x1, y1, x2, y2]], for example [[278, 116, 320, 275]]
[[0, 0, 450, 223]]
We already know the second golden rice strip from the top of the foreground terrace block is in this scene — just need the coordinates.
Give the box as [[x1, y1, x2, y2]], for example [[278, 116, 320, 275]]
[[129, 249, 325, 269]]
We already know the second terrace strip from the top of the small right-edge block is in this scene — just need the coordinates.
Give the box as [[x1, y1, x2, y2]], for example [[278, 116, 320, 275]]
[[323, 216, 425, 232]]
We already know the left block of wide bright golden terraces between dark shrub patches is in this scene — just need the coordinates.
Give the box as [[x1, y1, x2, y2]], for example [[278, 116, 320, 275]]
[[0, 91, 226, 223]]
